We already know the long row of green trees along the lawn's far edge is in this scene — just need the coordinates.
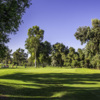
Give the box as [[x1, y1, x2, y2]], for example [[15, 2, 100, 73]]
[[0, 19, 100, 68]]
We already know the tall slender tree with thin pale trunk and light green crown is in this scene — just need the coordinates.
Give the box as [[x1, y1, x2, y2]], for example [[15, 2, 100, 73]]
[[25, 26, 44, 67]]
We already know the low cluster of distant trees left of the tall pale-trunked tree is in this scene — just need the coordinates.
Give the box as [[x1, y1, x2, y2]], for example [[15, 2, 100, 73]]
[[0, 48, 28, 66]]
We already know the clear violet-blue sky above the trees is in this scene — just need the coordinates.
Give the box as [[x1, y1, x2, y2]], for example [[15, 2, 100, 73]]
[[7, 0, 100, 52]]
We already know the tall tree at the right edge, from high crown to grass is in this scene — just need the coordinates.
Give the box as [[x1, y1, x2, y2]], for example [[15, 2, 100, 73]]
[[75, 19, 100, 67]]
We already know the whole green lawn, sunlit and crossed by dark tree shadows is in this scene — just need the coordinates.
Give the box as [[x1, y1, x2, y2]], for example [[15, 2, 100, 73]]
[[0, 67, 100, 100]]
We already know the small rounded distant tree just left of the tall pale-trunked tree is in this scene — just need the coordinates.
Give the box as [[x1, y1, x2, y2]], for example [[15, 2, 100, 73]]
[[13, 48, 28, 65]]
